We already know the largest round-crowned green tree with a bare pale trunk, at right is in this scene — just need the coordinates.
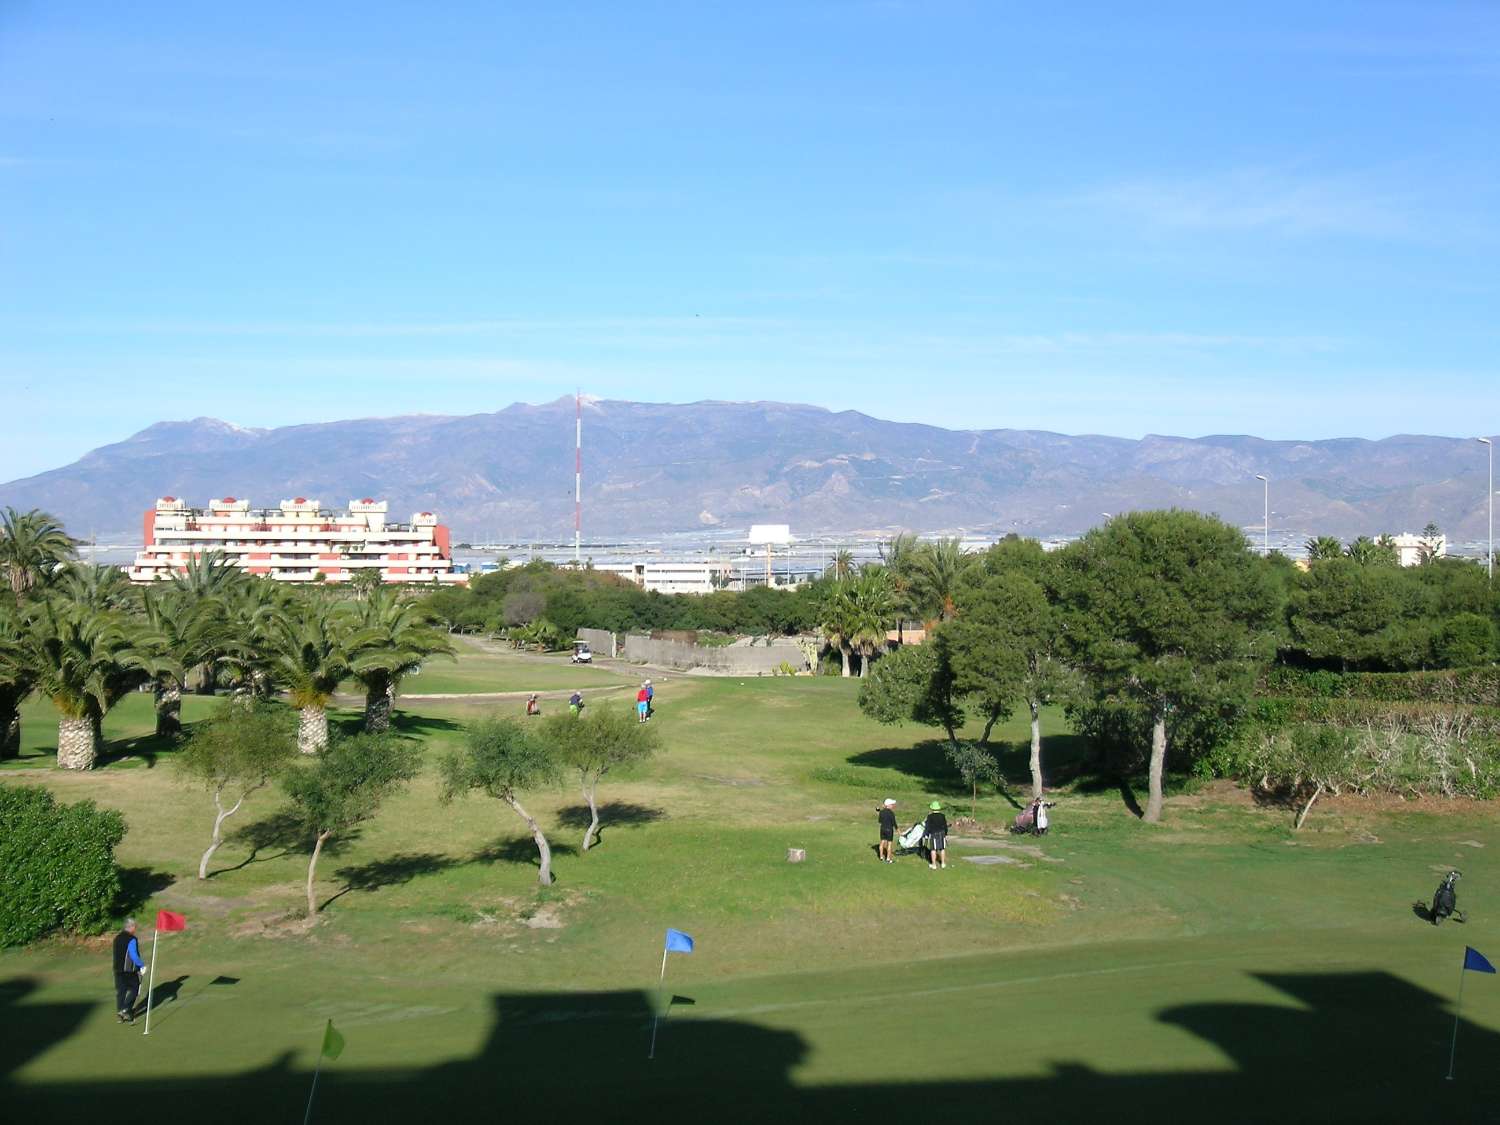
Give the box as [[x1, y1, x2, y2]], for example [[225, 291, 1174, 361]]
[[1059, 510, 1275, 822]]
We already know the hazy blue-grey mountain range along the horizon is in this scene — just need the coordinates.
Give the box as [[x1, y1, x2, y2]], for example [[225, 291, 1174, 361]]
[[0, 398, 1485, 542]]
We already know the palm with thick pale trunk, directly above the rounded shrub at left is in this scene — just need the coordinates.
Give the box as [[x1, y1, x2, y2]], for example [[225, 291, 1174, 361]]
[[21, 597, 161, 770]]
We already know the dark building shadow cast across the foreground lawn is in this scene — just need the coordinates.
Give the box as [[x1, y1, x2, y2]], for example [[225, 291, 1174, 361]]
[[0, 972, 1500, 1125]]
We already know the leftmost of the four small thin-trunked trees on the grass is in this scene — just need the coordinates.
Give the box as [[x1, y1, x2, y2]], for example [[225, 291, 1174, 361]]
[[176, 704, 297, 879]]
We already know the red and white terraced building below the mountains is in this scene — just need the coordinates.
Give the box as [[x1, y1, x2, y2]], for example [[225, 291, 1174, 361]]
[[129, 497, 468, 584]]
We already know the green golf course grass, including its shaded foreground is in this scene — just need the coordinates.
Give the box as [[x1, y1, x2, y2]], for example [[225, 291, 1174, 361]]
[[0, 669, 1500, 1122]]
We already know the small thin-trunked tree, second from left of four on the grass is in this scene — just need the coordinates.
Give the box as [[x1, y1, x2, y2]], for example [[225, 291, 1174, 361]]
[[282, 735, 422, 918]]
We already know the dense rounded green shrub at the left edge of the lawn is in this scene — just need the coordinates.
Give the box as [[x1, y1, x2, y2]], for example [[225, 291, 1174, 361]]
[[0, 785, 125, 947]]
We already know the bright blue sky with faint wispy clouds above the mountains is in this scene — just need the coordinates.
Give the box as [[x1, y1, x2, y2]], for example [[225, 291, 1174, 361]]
[[0, 0, 1500, 480]]
